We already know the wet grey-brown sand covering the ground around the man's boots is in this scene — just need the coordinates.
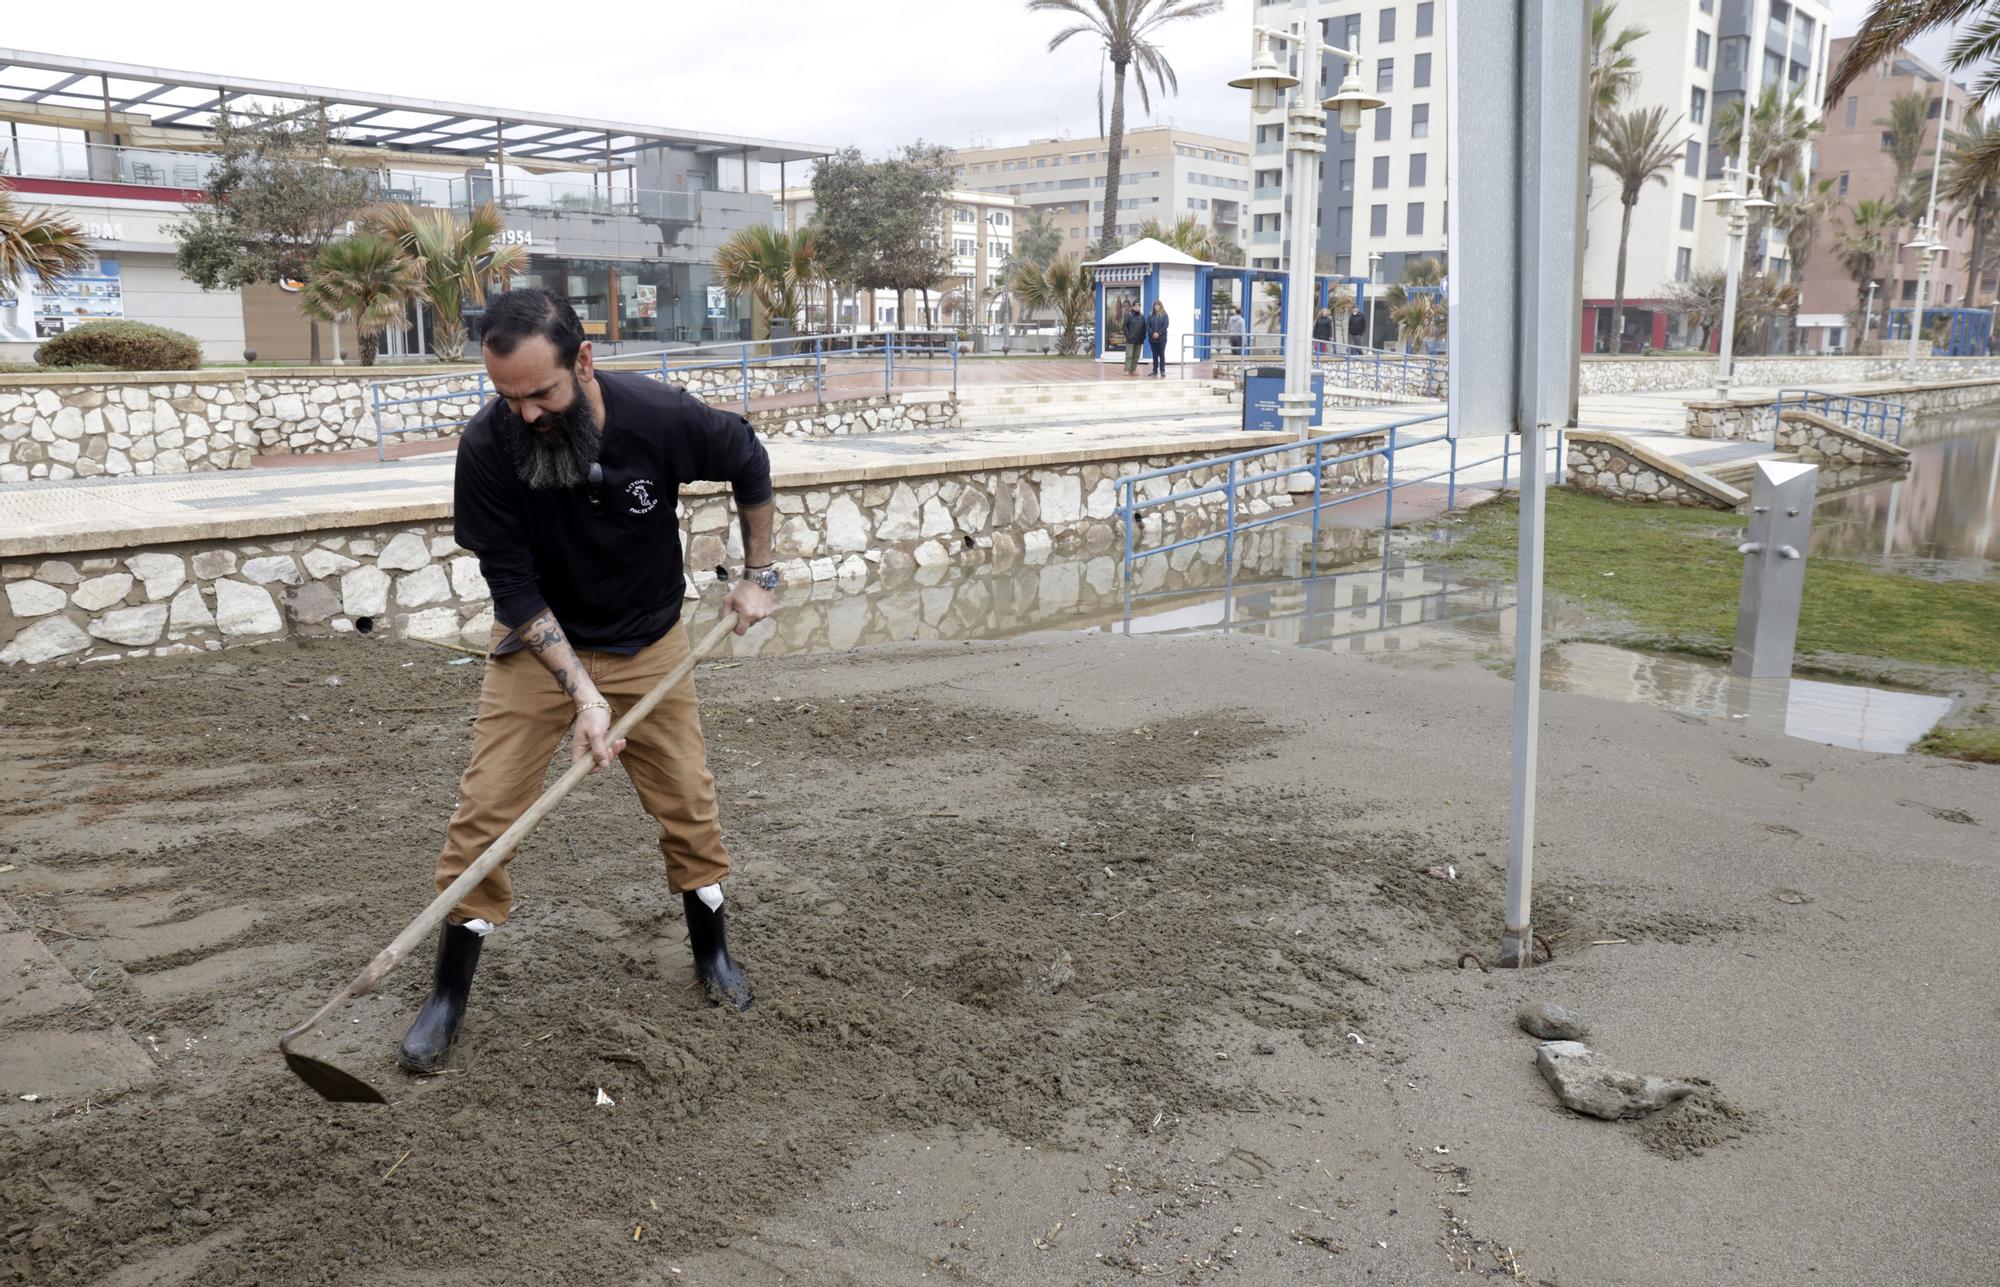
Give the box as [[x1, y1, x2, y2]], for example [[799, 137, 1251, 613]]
[[0, 619, 2000, 1287]]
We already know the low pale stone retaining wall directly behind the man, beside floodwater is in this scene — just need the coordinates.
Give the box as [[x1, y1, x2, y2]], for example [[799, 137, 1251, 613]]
[[0, 437, 1380, 665]]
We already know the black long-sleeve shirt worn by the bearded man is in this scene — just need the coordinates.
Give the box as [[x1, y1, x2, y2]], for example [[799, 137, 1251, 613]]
[[452, 370, 772, 651]]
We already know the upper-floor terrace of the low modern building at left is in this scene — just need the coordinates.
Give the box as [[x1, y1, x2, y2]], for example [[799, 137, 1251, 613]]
[[0, 138, 700, 224]]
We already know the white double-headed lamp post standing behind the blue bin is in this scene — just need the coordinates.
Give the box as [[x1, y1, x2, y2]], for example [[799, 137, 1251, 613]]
[[1230, 0, 1382, 442]]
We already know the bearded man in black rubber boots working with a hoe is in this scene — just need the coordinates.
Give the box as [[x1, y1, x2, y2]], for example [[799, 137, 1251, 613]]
[[398, 288, 778, 1073]]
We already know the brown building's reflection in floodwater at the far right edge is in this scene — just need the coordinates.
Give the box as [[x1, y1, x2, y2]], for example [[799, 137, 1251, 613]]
[[1812, 401, 2000, 580]]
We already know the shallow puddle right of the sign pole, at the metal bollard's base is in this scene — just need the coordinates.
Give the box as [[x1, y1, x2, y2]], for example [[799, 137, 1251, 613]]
[[1542, 644, 1952, 753]]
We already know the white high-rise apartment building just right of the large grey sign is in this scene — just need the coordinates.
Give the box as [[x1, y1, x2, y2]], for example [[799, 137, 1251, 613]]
[[1584, 0, 1832, 352]]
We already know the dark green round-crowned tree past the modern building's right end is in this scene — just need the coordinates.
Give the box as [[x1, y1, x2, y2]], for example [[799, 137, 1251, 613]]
[[812, 140, 952, 327]]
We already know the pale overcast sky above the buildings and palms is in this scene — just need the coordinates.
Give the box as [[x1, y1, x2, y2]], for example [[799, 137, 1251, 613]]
[[6, 0, 1944, 152]]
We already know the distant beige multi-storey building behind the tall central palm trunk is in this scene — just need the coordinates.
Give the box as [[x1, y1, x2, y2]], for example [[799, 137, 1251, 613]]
[[952, 126, 1250, 258]]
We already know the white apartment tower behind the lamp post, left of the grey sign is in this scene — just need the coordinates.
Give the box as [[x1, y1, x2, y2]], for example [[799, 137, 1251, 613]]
[[1250, 0, 1450, 282]]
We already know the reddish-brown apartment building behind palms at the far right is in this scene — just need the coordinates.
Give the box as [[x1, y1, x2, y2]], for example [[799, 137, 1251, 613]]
[[1798, 36, 1996, 350]]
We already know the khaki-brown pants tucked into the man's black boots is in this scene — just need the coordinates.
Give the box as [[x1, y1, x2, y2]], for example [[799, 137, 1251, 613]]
[[438, 624, 730, 925]]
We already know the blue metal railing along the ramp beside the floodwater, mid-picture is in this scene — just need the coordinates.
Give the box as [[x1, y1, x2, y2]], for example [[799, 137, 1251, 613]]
[[1116, 412, 1562, 576]]
